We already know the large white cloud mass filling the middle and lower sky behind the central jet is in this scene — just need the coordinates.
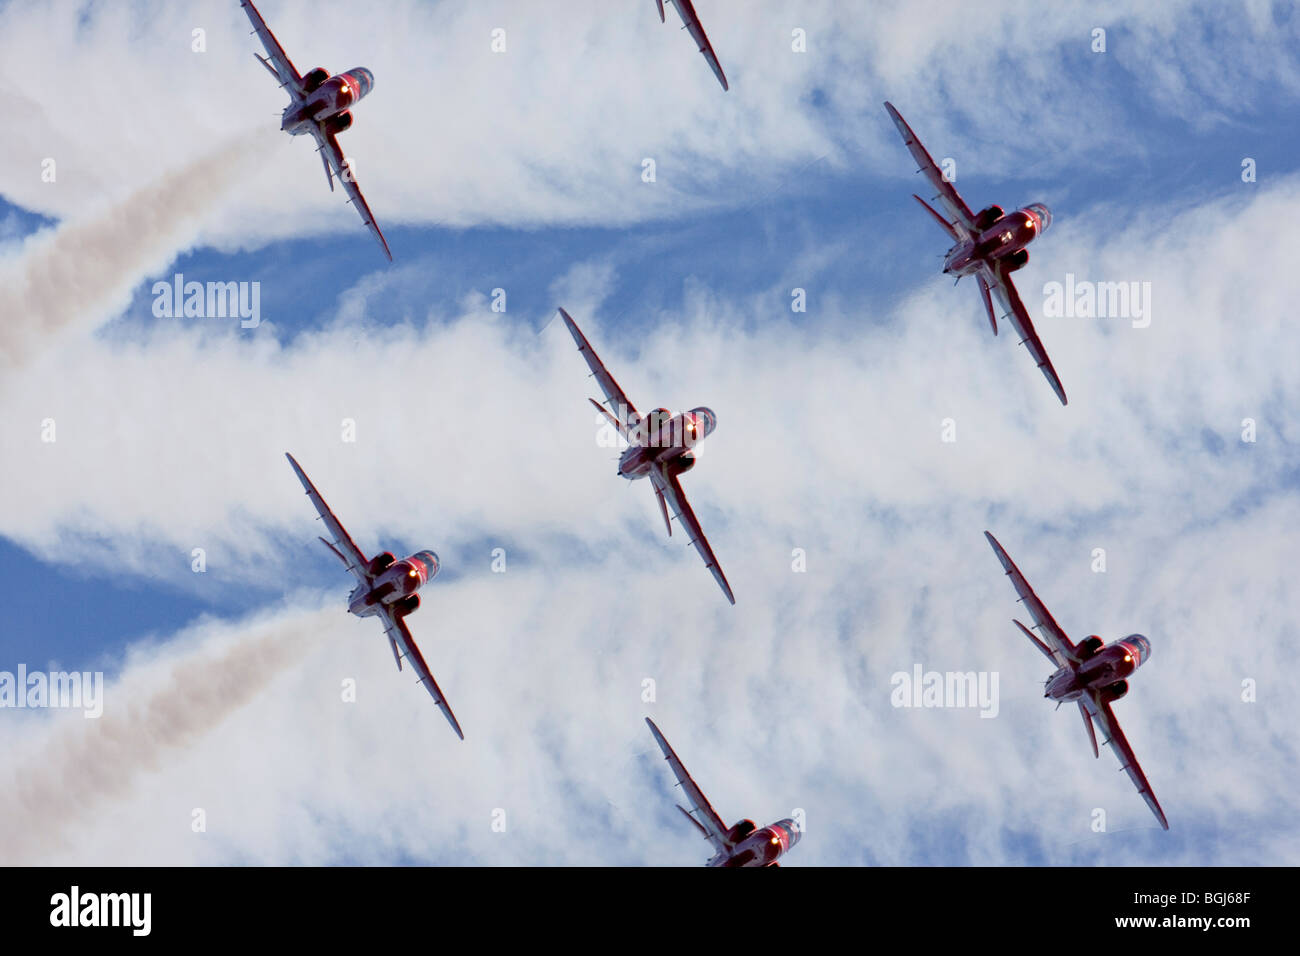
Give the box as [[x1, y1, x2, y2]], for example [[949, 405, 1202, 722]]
[[0, 160, 1300, 864]]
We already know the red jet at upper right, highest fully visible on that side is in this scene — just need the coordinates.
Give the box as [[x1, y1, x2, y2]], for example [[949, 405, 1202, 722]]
[[885, 103, 1066, 405]]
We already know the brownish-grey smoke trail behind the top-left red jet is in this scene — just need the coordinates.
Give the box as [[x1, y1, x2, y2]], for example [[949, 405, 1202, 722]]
[[0, 131, 274, 365]]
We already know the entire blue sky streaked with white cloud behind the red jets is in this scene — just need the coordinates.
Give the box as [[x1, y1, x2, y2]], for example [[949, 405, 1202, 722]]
[[0, 0, 1300, 865]]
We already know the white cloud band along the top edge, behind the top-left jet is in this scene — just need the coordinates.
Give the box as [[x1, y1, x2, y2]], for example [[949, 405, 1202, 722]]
[[0, 0, 1300, 256]]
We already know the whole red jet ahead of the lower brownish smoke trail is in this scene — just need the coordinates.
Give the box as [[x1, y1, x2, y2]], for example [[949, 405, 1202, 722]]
[[285, 451, 465, 740]]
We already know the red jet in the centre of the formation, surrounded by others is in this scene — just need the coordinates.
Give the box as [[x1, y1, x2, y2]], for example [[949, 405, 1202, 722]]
[[560, 308, 736, 604]]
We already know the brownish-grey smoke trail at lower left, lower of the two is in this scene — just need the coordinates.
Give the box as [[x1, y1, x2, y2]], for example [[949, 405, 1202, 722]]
[[0, 607, 338, 865]]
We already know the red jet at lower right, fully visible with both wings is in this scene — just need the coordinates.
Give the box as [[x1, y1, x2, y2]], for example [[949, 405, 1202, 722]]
[[984, 531, 1169, 830]]
